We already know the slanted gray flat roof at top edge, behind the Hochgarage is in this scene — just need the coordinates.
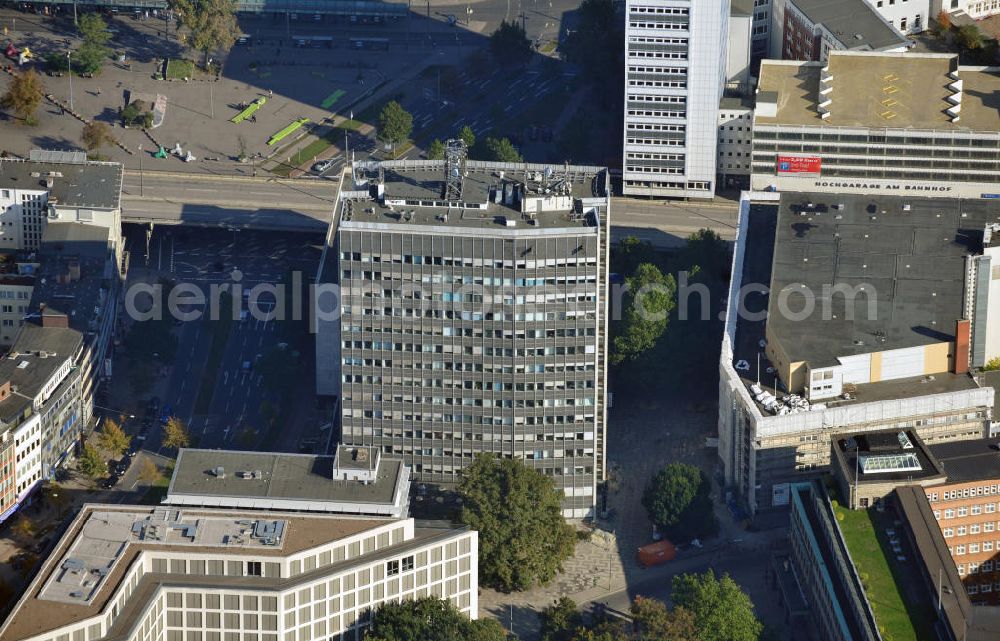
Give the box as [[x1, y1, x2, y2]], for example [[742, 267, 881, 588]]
[[792, 0, 907, 51]]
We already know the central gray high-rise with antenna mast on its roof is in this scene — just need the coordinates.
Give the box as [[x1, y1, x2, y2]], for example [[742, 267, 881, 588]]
[[317, 150, 610, 517]]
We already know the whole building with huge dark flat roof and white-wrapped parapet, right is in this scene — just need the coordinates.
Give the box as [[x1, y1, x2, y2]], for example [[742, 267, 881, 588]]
[[719, 193, 998, 512]]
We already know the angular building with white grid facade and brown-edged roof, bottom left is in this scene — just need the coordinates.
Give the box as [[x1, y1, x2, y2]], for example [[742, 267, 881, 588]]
[[0, 505, 478, 641]]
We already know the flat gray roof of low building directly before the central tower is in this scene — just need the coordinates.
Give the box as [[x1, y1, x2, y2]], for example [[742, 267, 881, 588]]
[[167, 448, 403, 505]]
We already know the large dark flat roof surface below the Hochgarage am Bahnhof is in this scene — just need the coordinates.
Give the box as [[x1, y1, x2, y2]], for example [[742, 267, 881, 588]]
[[767, 193, 1000, 367]]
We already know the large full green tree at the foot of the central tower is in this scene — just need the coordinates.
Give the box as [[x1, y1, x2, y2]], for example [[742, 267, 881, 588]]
[[458, 454, 576, 592]]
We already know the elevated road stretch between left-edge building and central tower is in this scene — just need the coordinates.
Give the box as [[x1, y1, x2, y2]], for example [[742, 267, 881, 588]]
[[122, 170, 339, 232]]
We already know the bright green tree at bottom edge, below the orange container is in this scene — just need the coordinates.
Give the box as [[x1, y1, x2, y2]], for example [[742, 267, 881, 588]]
[[671, 570, 764, 641]]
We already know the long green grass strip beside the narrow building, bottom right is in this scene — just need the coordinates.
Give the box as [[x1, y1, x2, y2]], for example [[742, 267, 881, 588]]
[[833, 502, 935, 641]]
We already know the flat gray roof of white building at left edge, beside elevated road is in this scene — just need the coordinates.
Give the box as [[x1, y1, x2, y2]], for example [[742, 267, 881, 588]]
[[0, 158, 122, 209]]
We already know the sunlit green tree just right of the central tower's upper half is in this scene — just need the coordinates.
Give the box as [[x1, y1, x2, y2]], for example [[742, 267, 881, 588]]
[[611, 263, 677, 365]]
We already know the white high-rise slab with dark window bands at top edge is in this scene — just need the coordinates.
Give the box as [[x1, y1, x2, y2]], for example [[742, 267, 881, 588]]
[[622, 0, 730, 198]]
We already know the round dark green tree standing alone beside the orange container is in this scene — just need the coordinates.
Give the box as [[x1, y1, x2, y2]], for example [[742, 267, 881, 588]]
[[642, 463, 718, 540]]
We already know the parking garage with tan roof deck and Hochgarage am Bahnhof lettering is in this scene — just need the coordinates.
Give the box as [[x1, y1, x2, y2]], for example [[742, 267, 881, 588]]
[[751, 51, 1000, 198]]
